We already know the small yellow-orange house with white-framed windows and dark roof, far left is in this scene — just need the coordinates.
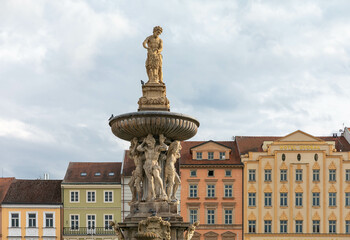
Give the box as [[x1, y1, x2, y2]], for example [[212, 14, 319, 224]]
[[1, 180, 62, 240]]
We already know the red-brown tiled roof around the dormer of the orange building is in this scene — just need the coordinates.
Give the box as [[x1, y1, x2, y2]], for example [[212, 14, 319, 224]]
[[180, 141, 241, 165]]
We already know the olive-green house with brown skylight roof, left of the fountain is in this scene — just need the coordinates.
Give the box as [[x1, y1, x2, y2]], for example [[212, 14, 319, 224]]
[[62, 162, 121, 240]]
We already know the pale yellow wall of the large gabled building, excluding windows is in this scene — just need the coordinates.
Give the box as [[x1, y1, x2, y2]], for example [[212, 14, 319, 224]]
[[242, 132, 350, 239]]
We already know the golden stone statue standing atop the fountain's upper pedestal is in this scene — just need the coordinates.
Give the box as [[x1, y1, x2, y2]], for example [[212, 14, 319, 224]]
[[142, 26, 163, 83]]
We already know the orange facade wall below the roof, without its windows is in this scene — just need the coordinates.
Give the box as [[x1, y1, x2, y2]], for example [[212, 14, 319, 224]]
[[181, 165, 242, 240]]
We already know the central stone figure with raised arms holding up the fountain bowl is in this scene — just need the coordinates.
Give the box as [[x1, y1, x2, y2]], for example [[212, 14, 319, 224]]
[[137, 134, 168, 201]]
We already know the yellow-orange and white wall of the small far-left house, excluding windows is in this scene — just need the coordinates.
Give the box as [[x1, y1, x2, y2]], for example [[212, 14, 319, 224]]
[[1, 205, 61, 240]]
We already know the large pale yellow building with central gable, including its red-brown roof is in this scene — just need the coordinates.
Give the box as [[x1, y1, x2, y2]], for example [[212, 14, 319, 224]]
[[236, 131, 350, 240]]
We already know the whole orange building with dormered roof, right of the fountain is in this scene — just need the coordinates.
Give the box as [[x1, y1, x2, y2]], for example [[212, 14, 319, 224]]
[[180, 141, 243, 240]]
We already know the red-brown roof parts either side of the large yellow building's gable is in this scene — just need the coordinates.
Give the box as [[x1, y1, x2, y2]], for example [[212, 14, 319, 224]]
[[236, 136, 350, 155]]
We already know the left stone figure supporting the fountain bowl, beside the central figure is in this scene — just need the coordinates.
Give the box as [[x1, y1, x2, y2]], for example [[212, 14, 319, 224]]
[[128, 137, 143, 202]]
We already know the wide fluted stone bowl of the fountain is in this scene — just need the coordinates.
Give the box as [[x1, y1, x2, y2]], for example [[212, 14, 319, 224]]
[[109, 111, 199, 141]]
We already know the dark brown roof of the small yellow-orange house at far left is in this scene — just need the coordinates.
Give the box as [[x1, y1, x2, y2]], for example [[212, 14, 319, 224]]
[[3, 179, 62, 204]]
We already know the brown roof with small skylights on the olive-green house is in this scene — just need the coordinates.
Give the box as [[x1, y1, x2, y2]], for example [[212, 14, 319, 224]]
[[62, 162, 122, 183]]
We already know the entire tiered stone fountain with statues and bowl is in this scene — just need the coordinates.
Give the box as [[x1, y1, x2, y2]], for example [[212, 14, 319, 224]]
[[109, 26, 199, 240]]
